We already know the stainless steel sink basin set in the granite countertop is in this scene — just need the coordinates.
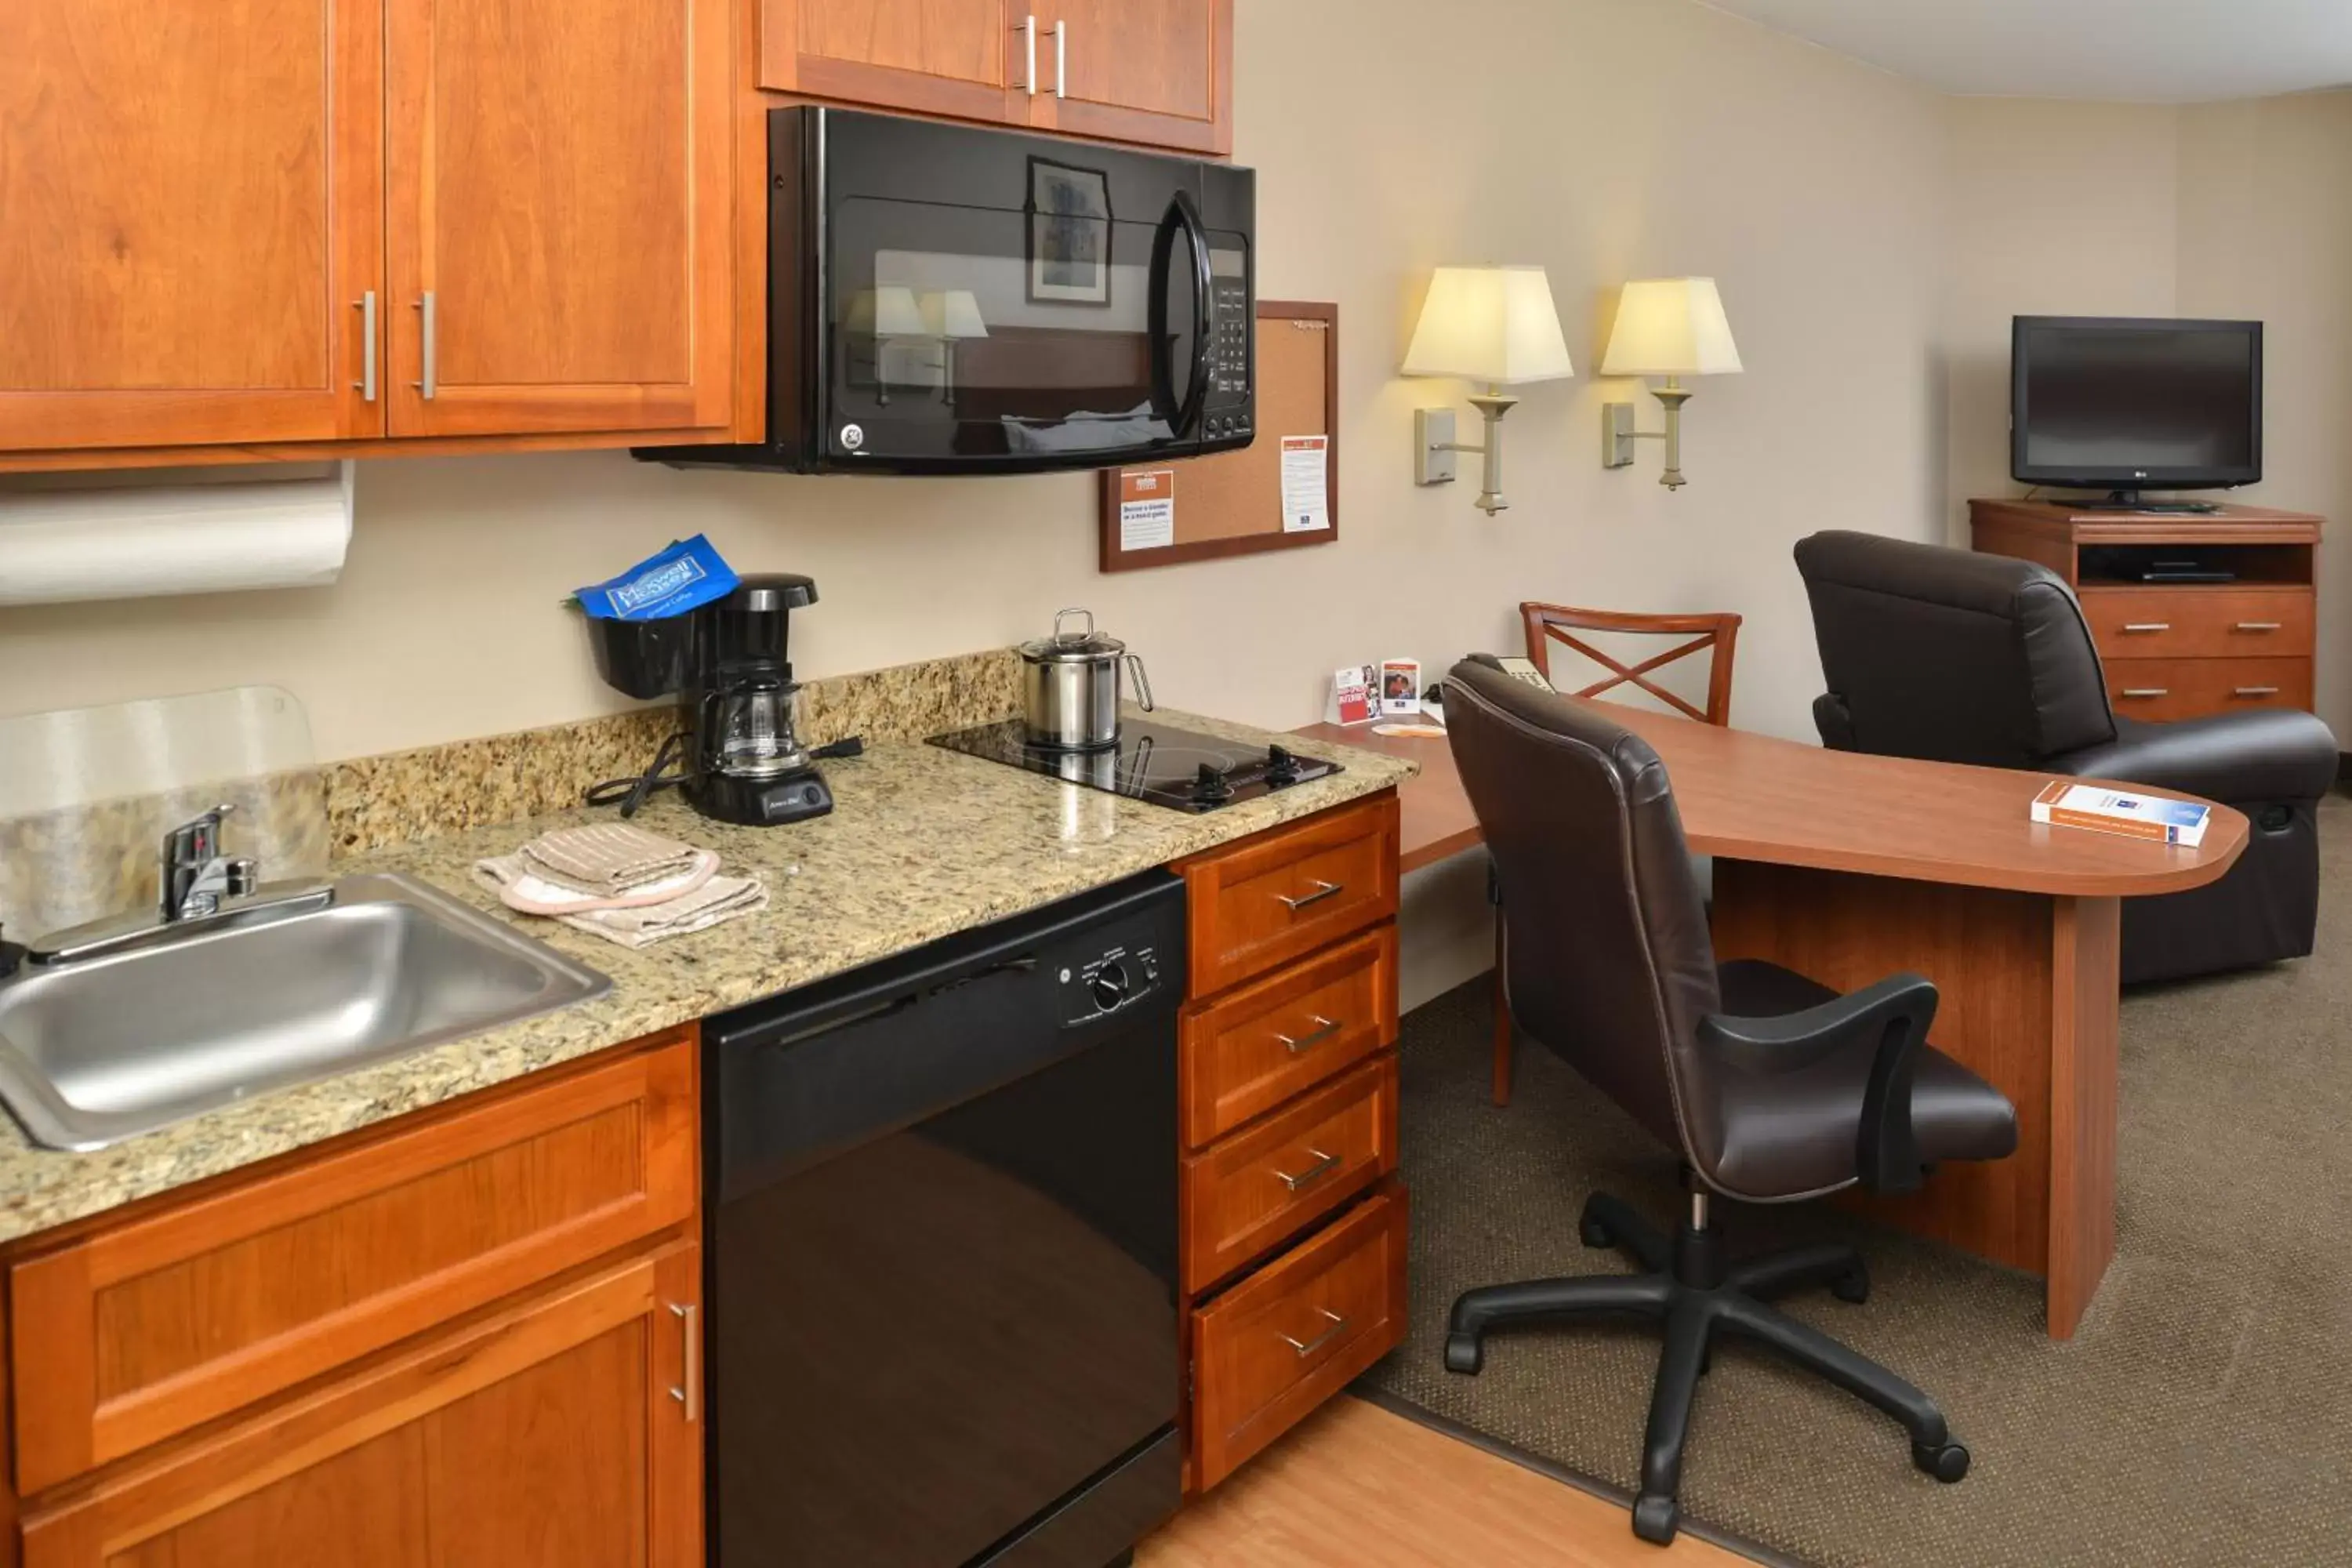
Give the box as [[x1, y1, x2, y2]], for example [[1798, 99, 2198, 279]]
[[0, 877, 612, 1149]]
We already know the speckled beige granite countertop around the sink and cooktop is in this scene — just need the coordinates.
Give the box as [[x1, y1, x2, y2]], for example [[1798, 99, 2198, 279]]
[[0, 710, 1414, 1241]]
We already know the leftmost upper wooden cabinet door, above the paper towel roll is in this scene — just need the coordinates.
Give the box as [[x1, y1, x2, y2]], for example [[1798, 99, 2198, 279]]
[[0, 0, 383, 449]]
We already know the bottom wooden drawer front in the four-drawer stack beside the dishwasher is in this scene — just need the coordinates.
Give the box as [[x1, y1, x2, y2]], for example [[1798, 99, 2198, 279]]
[[1192, 1185, 1406, 1490]]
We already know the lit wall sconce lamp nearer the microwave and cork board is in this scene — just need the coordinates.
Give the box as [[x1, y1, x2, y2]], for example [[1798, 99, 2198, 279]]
[[1404, 266, 1576, 517]]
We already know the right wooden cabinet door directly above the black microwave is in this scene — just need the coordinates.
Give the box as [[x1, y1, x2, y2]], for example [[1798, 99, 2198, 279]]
[[1040, 0, 1232, 153]]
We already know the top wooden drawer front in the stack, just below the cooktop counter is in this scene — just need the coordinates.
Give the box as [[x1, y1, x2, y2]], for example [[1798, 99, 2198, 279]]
[[1178, 792, 1397, 996]]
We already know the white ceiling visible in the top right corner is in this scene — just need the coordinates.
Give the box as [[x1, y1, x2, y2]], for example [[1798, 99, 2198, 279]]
[[1703, 0, 2352, 103]]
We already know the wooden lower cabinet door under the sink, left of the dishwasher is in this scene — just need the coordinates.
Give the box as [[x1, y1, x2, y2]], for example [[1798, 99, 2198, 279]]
[[24, 1241, 703, 1568]]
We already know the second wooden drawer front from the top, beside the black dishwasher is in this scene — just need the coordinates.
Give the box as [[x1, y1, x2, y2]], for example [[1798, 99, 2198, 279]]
[[1183, 921, 1397, 1149]]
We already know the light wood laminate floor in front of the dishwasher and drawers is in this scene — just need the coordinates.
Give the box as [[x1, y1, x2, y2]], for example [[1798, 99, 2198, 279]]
[[1136, 1399, 1752, 1568]]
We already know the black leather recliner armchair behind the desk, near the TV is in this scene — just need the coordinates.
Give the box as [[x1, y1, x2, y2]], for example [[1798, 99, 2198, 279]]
[[1797, 532, 2338, 982]]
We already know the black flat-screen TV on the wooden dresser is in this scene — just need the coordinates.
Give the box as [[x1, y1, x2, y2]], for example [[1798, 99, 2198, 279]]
[[2009, 315, 2263, 503]]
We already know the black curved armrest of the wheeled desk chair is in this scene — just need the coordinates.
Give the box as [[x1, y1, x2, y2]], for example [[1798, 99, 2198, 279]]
[[1698, 973, 1936, 1192]]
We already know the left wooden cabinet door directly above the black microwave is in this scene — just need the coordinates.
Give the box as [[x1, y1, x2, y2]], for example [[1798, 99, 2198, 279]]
[[760, 0, 1035, 125]]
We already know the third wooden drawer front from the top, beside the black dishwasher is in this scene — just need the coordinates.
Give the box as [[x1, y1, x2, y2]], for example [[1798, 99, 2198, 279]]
[[1183, 1053, 1397, 1290]]
